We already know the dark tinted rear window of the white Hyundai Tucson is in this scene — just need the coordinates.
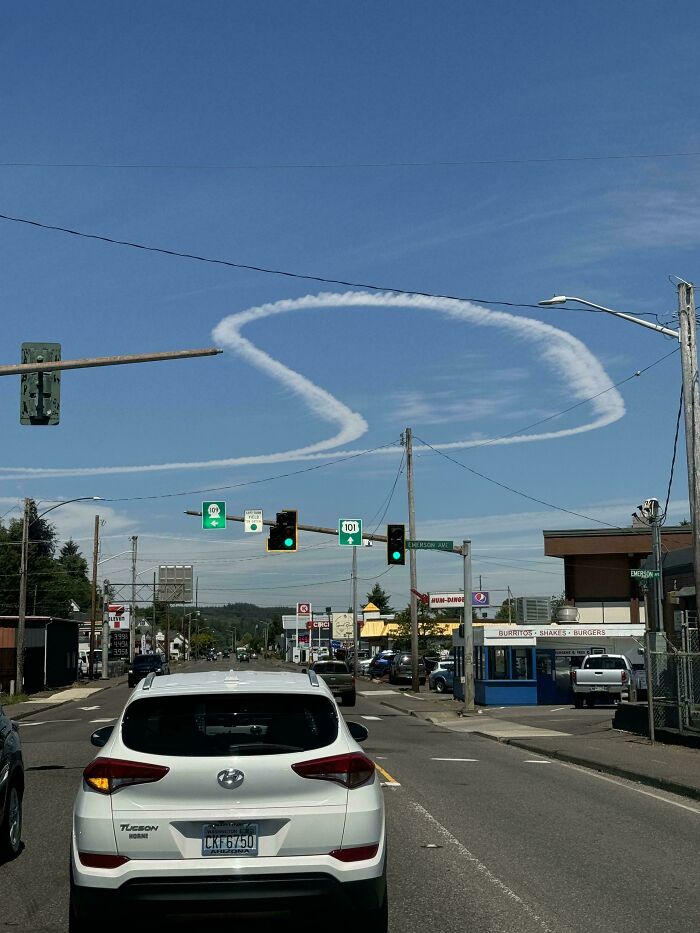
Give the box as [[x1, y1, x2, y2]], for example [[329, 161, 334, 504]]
[[122, 693, 338, 757]]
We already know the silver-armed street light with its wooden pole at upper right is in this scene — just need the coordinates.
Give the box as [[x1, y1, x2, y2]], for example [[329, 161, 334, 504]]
[[538, 281, 700, 627]]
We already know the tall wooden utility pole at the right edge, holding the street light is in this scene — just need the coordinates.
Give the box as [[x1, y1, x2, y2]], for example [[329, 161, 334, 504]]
[[678, 282, 700, 594]]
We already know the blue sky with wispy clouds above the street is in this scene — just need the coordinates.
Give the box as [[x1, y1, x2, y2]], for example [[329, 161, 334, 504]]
[[0, 0, 700, 609]]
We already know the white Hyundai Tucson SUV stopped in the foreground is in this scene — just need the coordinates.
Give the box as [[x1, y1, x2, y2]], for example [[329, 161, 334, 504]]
[[70, 670, 387, 933]]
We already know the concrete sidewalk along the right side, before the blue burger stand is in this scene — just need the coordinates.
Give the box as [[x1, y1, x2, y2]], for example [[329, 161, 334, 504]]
[[368, 684, 700, 800]]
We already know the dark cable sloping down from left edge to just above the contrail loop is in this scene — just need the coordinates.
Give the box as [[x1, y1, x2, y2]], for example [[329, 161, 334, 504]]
[[0, 214, 568, 312]]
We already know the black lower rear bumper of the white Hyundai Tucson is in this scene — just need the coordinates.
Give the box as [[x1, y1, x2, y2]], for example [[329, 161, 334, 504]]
[[71, 872, 386, 919]]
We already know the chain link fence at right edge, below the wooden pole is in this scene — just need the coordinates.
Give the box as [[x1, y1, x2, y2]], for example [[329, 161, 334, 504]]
[[649, 613, 700, 734]]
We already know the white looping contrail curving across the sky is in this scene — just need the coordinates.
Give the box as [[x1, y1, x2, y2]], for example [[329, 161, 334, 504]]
[[0, 292, 625, 479]]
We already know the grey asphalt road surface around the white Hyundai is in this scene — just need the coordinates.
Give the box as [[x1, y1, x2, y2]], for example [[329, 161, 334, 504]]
[[0, 664, 700, 933]]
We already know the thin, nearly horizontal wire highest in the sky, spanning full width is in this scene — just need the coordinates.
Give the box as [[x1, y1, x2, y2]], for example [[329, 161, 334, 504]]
[[0, 151, 700, 171]]
